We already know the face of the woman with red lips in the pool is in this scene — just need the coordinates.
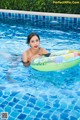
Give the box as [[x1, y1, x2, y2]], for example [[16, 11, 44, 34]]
[[29, 36, 40, 49]]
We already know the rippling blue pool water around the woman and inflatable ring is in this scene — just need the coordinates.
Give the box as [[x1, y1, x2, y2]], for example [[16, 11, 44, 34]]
[[0, 10, 80, 120]]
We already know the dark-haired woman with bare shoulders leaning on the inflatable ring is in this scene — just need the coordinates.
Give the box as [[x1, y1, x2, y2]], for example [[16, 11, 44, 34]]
[[22, 33, 49, 66]]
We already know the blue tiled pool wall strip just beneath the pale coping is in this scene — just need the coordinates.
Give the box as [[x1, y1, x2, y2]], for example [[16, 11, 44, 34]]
[[0, 11, 80, 23]]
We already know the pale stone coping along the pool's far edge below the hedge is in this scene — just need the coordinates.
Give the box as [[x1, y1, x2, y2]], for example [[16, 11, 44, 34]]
[[0, 9, 80, 18]]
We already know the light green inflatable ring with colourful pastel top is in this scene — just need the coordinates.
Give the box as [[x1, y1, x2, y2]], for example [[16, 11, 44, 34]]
[[31, 50, 80, 71]]
